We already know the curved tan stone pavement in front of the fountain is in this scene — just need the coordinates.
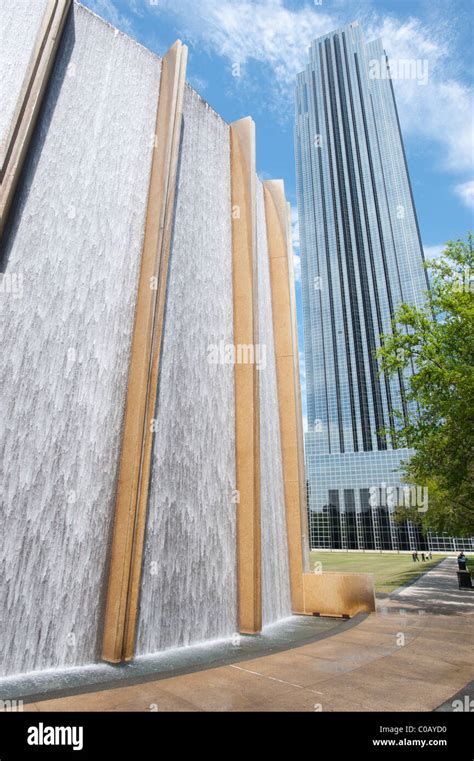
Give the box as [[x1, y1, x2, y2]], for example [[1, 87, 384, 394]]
[[25, 558, 474, 711]]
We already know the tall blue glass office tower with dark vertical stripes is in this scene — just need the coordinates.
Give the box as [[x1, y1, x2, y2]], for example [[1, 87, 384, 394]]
[[295, 22, 427, 549]]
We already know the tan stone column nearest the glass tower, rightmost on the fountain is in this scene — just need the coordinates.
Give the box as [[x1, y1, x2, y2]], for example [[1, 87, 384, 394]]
[[263, 180, 309, 613]]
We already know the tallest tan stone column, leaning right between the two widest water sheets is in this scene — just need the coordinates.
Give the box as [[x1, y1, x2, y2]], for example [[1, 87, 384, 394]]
[[102, 41, 187, 663]]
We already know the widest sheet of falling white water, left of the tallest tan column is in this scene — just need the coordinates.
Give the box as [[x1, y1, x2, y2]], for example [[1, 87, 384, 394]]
[[0, 6, 160, 675]]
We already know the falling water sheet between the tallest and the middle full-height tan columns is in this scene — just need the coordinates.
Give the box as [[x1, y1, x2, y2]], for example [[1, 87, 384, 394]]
[[137, 88, 237, 654]]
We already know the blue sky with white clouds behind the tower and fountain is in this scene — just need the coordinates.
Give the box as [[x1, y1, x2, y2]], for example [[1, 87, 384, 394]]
[[82, 0, 474, 424]]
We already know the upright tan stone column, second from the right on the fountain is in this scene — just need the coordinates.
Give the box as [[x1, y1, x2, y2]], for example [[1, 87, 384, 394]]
[[231, 117, 262, 634]]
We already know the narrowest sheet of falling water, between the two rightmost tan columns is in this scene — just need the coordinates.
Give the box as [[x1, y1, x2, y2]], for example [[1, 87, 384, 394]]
[[257, 181, 291, 626]]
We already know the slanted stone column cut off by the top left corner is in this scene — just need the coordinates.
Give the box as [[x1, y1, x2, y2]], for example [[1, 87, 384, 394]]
[[0, 0, 71, 238]]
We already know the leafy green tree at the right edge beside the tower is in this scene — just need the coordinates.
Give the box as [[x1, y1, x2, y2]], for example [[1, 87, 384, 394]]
[[378, 234, 474, 536]]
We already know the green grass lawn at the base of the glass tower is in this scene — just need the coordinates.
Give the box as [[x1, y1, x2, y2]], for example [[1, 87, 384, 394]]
[[310, 550, 446, 594]]
